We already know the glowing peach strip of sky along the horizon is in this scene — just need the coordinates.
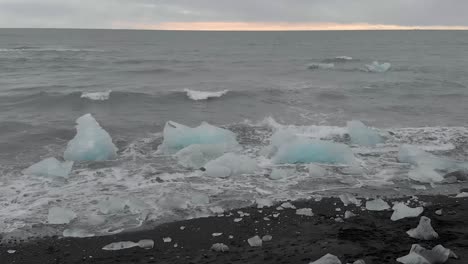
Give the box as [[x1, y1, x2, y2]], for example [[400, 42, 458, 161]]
[[112, 21, 468, 31]]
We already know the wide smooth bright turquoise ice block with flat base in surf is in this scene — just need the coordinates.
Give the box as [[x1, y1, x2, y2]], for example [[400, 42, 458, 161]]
[[273, 138, 355, 164]]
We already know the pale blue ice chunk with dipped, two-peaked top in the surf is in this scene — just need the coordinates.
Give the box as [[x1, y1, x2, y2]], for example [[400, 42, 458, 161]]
[[158, 121, 238, 154]]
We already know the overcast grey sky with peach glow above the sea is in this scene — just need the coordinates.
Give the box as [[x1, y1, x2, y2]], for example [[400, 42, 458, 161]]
[[0, 0, 468, 30]]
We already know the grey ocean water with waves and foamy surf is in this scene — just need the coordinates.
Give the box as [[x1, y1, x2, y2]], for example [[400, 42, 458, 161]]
[[0, 29, 468, 239]]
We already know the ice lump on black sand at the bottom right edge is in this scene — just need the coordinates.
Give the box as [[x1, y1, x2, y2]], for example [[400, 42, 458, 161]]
[[397, 244, 458, 264]]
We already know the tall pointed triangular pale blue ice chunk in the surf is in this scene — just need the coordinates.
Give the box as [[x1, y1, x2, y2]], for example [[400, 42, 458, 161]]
[[63, 114, 117, 161]]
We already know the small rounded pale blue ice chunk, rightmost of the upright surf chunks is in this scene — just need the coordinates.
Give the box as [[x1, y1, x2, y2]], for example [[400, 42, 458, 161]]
[[347, 120, 384, 147]]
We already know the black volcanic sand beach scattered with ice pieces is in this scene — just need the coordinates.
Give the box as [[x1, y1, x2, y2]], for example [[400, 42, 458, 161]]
[[0, 196, 468, 264]]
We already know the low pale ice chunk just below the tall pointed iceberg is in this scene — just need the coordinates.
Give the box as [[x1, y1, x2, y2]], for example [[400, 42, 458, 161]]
[[23, 158, 73, 178]]
